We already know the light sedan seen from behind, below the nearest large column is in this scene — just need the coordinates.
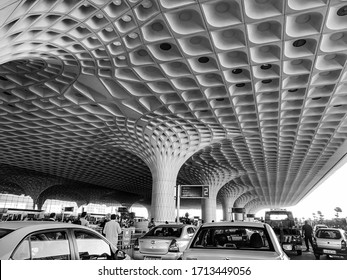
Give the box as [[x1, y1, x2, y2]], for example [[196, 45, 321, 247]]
[[133, 224, 196, 260]]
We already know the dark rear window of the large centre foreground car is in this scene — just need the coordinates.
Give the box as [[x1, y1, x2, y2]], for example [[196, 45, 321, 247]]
[[191, 226, 274, 251]]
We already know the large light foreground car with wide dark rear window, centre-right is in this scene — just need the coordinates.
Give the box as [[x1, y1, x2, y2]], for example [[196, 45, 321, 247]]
[[181, 222, 289, 260]]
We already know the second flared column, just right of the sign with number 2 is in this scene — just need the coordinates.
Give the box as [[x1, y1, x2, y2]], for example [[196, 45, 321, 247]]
[[217, 178, 249, 221]]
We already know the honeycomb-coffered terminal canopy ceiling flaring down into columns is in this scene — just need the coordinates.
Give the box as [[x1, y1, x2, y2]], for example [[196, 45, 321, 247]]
[[0, 0, 347, 218]]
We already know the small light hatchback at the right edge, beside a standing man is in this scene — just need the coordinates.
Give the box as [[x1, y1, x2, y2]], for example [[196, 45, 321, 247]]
[[313, 228, 347, 260]]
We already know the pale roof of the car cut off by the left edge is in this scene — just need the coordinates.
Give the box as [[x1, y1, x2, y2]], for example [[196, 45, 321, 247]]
[[0, 221, 86, 230]]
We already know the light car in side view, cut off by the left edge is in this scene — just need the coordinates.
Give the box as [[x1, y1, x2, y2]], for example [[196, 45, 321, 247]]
[[0, 221, 130, 260]]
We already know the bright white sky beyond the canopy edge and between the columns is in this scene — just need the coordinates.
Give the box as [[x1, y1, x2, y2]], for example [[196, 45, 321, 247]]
[[132, 163, 347, 221]]
